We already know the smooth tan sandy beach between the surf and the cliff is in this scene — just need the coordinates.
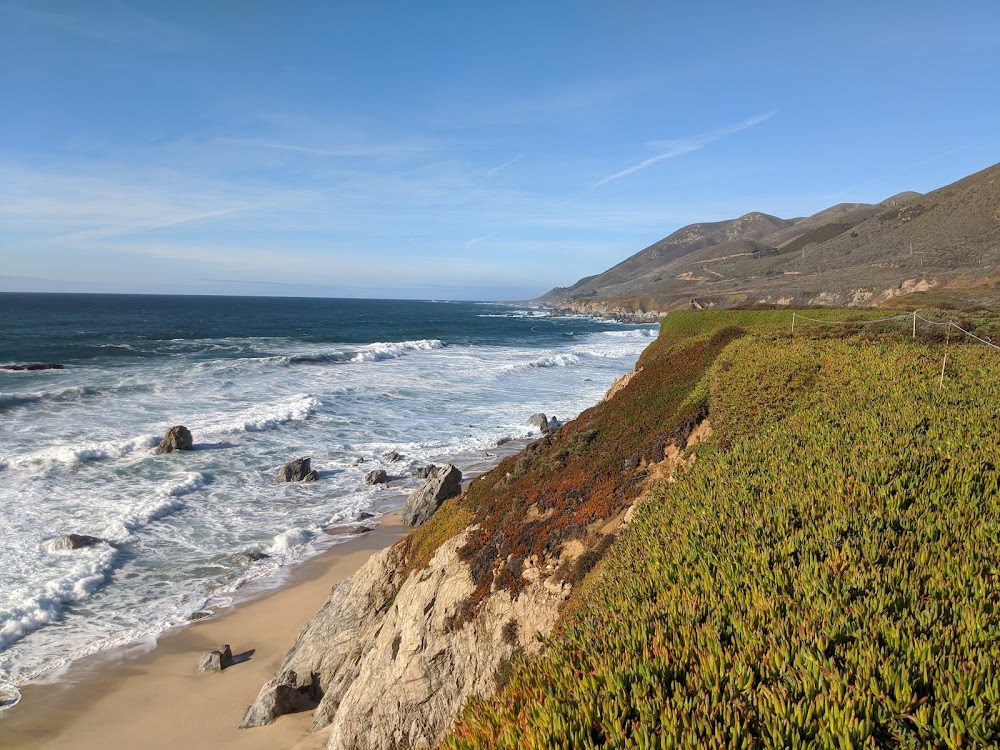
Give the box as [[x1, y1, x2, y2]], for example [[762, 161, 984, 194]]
[[0, 512, 409, 750]]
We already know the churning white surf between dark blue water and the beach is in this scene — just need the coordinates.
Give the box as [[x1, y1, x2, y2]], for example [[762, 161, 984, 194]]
[[0, 320, 650, 684]]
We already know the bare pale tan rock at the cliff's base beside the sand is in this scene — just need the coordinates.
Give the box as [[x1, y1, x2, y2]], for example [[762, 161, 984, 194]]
[[243, 532, 570, 750]]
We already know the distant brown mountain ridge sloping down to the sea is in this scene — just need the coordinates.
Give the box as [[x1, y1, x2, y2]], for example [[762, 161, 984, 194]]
[[535, 164, 1000, 312]]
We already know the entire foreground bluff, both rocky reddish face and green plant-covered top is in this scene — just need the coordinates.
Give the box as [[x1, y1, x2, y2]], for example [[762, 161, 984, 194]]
[[247, 308, 1000, 750]]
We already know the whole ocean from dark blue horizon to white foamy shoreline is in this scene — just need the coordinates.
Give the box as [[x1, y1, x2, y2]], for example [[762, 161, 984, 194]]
[[0, 294, 656, 707]]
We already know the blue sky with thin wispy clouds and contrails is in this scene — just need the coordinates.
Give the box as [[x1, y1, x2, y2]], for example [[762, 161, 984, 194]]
[[0, 0, 1000, 300]]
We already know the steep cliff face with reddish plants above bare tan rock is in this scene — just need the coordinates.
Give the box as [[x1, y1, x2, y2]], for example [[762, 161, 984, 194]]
[[244, 329, 739, 750]]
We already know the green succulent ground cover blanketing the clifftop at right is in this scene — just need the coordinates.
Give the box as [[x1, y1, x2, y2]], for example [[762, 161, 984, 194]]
[[444, 311, 1000, 748]]
